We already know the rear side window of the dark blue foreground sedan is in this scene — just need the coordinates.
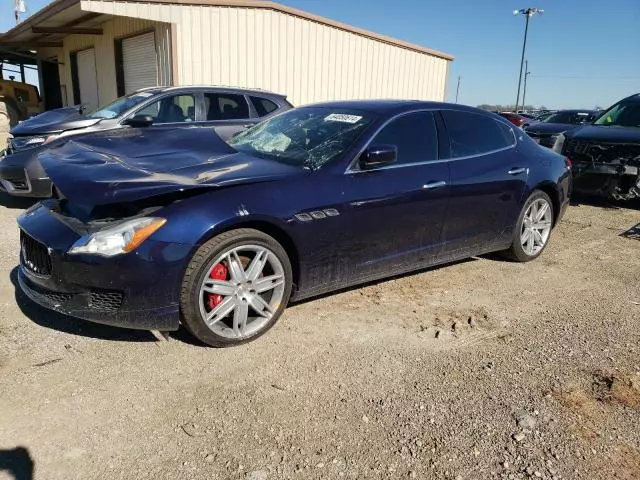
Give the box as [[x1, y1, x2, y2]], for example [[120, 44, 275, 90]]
[[442, 110, 515, 158]]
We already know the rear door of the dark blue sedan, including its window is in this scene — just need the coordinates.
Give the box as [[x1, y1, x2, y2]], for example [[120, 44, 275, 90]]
[[441, 110, 529, 258]]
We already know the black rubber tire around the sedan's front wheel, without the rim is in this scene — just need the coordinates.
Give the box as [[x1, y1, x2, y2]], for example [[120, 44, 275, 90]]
[[180, 228, 293, 347]]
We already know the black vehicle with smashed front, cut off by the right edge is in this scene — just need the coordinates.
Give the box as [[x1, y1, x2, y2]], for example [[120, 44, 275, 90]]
[[554, 94, 640, 200]]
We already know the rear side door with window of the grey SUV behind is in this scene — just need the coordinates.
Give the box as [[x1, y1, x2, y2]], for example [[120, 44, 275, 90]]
[[198, 91, 258, 140]]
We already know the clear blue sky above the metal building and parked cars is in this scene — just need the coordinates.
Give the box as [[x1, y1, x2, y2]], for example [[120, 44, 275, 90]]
[[0, 0, 640, 108]]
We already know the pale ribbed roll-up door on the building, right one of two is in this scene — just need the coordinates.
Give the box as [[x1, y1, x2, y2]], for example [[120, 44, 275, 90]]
[[122, 32, 158, 93]]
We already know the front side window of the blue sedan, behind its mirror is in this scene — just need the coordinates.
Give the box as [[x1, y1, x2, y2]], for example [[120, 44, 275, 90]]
[[370, 112, 438, 164]]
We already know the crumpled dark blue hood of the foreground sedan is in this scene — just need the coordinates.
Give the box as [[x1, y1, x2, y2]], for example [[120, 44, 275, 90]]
[[38, 128, 306, 205]]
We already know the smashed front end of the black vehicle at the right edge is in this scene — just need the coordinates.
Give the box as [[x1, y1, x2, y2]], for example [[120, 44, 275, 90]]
[[562, 139, 640, 200]]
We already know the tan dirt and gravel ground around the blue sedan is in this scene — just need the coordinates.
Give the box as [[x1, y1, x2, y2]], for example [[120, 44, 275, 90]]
[[0, 196, 640, 480]]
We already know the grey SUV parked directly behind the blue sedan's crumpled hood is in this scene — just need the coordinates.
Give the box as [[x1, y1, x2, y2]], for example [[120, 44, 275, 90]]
[[0, 86, 291, 197]]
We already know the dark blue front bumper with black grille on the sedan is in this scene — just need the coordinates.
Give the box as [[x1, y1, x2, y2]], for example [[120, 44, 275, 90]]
[[18, 204, 193, 330]]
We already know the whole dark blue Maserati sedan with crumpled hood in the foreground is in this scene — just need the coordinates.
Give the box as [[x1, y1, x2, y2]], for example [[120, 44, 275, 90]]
[[19, 101, 571, 346]]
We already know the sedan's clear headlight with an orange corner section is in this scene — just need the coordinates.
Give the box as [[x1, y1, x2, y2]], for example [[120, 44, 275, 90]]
[[68, 217, 167, 257]]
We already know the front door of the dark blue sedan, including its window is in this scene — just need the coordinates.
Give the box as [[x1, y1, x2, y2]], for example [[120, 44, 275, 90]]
[[340, 111, 449, 279]]
